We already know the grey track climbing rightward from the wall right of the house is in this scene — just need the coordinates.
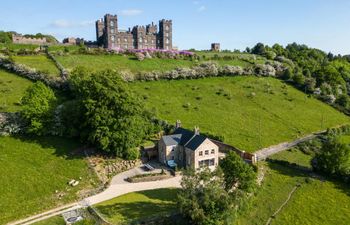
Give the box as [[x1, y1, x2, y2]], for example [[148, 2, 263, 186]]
[[255, 133, 320, 161]]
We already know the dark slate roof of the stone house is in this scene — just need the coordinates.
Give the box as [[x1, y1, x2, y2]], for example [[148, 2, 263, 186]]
[[162, 127, 207, 151]]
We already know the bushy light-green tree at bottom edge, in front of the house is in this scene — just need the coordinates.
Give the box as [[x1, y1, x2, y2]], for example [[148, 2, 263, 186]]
[[177, 168, 235, 225]]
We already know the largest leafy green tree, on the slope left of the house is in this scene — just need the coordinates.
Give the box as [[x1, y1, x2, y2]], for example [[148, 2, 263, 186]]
[[70, 69, 153, 159]]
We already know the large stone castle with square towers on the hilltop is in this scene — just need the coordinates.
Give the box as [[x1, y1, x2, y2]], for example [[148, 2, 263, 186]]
[[96, 14, 173, 50]]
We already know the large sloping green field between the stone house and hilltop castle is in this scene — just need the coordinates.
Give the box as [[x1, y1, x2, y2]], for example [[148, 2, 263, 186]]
[[130, 76, 349, 152]]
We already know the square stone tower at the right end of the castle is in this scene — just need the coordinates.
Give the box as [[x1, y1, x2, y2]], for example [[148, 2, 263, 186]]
[[157, 19, 173, 50]]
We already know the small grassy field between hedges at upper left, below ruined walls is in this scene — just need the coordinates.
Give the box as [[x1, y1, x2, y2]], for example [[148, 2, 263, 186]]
[[12, 55, 60, 77]]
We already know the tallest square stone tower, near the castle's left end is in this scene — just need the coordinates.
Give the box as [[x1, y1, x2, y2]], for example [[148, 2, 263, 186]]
[[104, 14, 118, 49]]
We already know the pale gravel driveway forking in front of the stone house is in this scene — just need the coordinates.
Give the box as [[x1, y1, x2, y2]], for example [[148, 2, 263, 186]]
[[8, 168, 181, 225]]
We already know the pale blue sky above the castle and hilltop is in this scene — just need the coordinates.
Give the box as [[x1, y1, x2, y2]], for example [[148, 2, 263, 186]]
[[0, 0, 350, 54]]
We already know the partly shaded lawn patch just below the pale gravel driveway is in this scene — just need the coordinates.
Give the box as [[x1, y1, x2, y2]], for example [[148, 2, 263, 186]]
[[95, 189, 177, 224]]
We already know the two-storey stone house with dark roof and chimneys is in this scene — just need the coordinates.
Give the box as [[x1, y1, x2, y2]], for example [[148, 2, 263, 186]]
[[158, 121, 219, 169]]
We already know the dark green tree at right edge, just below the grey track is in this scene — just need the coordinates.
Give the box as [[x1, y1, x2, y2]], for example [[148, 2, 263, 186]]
[[312, 137, 350, 177]]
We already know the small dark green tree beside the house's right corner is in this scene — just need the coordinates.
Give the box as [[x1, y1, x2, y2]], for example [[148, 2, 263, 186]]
[[220, 151, 256, 192]]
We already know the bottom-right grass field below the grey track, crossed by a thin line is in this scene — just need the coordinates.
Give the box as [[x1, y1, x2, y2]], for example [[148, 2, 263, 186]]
[[235, 150, 350, 225]]
